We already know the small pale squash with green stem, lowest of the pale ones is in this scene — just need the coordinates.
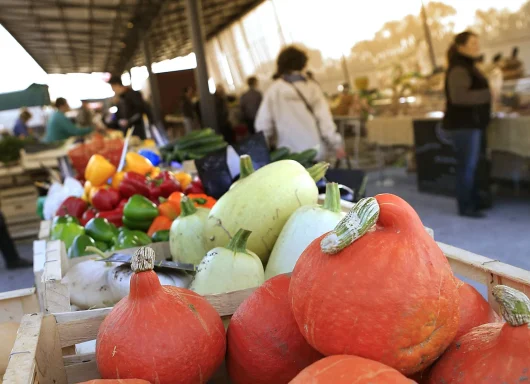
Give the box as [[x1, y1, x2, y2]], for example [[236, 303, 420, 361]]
[[190, 229, 265, 295]]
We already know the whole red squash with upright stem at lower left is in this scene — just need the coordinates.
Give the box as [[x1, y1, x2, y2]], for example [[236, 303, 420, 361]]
[[96, 247, 226, 384]]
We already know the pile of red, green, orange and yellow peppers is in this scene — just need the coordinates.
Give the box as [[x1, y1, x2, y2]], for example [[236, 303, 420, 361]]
[[51, 152, 215, 257]]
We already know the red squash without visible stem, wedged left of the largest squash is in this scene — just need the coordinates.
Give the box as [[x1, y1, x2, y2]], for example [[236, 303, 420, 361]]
[[226, 275, 322, 384]]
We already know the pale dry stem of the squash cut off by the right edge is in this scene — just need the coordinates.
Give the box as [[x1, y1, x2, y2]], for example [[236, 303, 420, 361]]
[[492, 285, 530, 327]]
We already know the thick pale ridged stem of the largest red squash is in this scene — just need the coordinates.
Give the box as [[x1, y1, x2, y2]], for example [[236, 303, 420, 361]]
[[320, 197, 379, 255]]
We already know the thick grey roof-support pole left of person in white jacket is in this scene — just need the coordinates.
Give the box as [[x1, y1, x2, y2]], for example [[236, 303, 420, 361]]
[[186, 0, 218, 132]]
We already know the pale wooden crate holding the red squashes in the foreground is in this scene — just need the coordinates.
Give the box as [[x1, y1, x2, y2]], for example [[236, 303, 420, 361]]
[[4, 243, 530, 384]]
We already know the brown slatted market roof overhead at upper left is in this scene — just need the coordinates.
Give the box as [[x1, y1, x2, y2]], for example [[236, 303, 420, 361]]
[[0, 0, 263, 73]]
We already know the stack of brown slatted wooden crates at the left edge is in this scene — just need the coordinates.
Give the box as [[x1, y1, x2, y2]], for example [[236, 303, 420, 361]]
[[0, 185, 40, 239]]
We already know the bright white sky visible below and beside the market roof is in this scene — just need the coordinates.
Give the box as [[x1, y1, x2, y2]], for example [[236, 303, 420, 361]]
[[0, 0, 526, 99]]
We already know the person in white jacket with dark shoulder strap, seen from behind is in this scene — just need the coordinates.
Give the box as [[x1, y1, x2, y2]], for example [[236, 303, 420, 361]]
[[255, 46, 345, 160]]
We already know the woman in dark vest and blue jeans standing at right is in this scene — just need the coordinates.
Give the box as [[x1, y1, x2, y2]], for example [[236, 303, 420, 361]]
[[444, 32, 491, 218]]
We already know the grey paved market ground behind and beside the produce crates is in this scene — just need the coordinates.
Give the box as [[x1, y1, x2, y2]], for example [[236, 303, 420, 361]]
[[0, 169, 530, 292]]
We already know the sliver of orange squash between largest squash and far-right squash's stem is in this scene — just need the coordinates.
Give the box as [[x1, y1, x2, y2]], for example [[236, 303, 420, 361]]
[[455, 279, 500, 339]]
